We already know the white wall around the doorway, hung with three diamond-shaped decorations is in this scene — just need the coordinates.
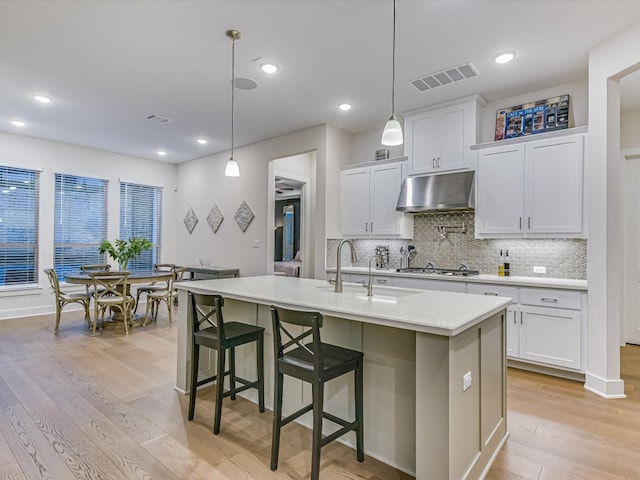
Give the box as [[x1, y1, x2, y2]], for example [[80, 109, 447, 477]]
[[174, 125, 351, 282]]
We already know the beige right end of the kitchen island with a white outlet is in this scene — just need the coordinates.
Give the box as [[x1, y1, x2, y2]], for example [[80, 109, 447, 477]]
[[416, 311, 507, 480]]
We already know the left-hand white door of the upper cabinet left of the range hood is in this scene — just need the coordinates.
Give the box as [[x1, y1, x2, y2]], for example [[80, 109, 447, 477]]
[[340, 167, 370, 236]]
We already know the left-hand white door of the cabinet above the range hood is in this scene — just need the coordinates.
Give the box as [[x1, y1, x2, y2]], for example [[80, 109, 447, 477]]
[[404, 111, 438, 174]]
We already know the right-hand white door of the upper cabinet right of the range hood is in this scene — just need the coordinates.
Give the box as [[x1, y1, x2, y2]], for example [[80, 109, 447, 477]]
[[525, 135, 583, 235]]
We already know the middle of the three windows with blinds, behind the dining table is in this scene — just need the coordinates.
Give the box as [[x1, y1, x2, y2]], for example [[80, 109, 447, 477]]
[[54, 173, 107, 279]]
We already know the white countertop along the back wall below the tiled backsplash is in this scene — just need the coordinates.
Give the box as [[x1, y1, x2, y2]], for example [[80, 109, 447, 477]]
[[327, 267, 587, 291]]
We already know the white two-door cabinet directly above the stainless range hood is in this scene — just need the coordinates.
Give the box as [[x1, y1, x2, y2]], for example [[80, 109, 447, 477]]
[[404, 95, 484, 175]]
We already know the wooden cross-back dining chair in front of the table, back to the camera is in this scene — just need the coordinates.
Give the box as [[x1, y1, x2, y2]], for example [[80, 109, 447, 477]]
[[88, 271, 135, 336]]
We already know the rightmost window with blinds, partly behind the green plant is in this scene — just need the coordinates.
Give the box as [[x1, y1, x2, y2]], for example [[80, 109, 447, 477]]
[[120, 182, 162, 270]]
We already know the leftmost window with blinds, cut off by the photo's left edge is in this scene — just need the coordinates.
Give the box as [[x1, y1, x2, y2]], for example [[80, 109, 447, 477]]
[[0, 166, 40, 285]]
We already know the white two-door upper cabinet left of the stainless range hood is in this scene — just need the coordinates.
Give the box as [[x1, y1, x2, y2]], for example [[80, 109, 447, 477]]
[[340, 161, 413, 238]]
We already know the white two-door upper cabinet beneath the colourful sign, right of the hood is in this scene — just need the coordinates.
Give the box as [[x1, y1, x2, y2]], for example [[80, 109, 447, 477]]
[[475, 129, 585, 238]]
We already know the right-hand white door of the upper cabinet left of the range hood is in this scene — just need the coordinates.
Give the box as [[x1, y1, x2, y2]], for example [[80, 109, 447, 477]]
[[369, 163, 402, 236]]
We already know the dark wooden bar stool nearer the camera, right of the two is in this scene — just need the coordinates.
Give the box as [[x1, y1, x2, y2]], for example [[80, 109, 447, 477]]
[[271, 306, 364, 480]]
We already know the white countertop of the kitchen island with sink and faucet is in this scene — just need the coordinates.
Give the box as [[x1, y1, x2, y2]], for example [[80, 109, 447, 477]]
[[175, 275, 511, 336]]
